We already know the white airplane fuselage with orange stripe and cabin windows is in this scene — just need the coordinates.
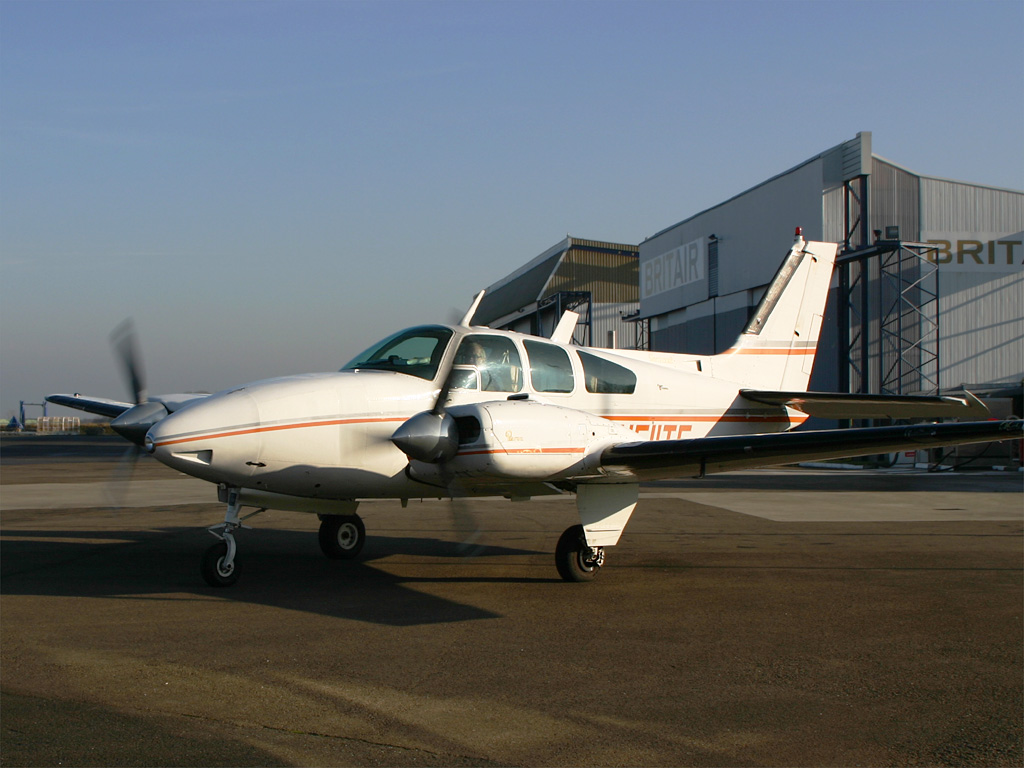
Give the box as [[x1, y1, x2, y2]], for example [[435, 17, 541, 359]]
[[147, 327, 806, 500]]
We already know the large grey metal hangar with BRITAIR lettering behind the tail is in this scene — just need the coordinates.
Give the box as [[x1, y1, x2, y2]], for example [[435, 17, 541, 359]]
[[624, 132, 1024, 411]]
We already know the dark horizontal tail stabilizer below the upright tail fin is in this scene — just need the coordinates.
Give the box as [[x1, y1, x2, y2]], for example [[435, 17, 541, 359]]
[[739, 389, 989, 420]]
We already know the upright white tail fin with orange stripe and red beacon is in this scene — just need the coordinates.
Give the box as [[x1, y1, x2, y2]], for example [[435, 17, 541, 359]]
[[714, 229, 839, 391]]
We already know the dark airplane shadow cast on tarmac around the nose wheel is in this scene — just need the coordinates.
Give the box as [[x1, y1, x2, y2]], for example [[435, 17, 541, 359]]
[[0, 527, 557, 627]]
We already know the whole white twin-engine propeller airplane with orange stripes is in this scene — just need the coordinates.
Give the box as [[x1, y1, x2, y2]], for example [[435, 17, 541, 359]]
[[47, 230, 1022, 587]]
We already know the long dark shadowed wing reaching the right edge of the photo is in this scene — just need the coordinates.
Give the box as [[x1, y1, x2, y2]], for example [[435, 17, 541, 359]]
[[601, 419, 1024, 480]]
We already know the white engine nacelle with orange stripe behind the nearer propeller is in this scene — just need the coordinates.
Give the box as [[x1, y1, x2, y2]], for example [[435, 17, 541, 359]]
[[412, 399, 636, 482]]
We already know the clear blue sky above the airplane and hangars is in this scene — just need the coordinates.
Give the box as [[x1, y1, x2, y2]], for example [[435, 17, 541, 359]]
[[0, 0, 1024, 418]]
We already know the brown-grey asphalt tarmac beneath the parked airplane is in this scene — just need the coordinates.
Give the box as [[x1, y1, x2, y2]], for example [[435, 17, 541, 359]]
[[0, 438, 1024, 766]]
